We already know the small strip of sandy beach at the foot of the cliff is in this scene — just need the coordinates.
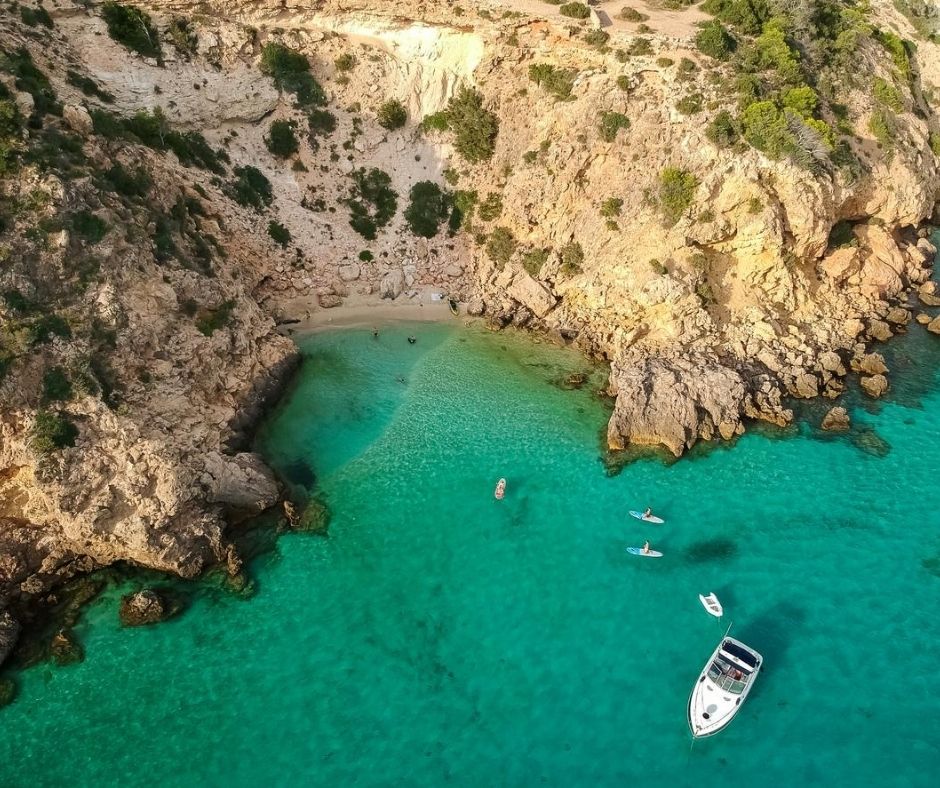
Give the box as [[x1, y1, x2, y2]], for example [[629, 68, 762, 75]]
[[281, 287, 467, 334]]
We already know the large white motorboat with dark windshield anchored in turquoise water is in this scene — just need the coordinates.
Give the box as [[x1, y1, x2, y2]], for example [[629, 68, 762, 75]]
[[689, 636, 764, 739]]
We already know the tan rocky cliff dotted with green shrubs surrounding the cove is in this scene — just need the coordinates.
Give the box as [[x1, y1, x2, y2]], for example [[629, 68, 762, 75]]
[[0, 0, 940, 664]]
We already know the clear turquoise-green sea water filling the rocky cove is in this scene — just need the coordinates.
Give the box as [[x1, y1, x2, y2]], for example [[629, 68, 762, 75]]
[[0, 325, 940, 786]]
